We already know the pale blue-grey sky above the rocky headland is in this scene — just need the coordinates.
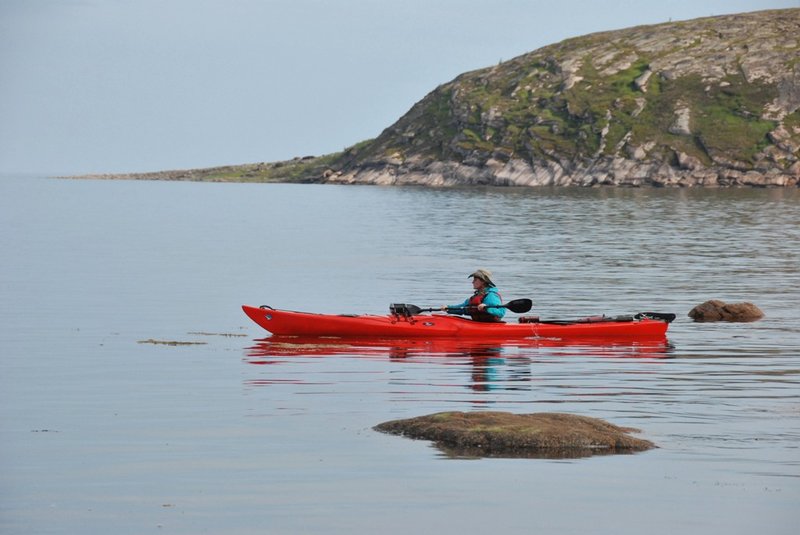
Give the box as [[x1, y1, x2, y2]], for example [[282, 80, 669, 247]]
[[0, 0, 800, 174]]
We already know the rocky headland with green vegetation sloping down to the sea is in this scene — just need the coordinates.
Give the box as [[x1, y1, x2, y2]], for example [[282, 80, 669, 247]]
[[75, 9, 800, 187]]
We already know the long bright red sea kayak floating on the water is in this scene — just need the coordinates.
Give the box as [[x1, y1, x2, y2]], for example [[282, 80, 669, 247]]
[[242, 305, 675, 340]]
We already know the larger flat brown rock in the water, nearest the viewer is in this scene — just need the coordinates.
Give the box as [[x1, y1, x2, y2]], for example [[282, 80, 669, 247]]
[[374, 412, 656, 458]]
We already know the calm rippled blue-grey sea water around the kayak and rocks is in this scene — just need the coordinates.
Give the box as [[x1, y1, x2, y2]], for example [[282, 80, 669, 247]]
[[0, 177, 800, 535]]
